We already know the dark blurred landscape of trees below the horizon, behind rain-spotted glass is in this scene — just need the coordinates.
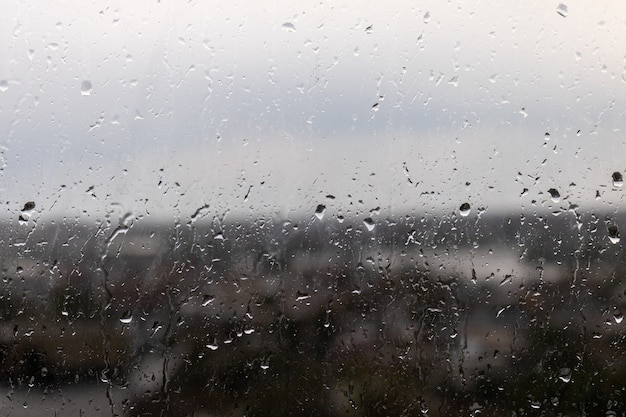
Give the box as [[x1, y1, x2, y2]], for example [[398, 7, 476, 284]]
[[0, 208, 626, 416]]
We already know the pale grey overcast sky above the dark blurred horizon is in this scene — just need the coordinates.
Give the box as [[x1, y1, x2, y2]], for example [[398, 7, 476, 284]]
[[0, 0, 626, 224]]
